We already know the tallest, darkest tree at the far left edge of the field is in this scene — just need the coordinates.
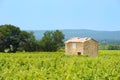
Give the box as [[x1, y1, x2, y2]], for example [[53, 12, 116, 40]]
[[0, 24, 20, 52]]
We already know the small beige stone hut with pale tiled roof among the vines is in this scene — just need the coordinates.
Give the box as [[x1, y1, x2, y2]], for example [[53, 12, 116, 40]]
[[65, 37, 98, 56]]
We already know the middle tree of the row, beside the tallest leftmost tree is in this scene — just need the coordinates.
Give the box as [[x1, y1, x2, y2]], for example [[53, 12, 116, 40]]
[[19, 31, 38, 51]]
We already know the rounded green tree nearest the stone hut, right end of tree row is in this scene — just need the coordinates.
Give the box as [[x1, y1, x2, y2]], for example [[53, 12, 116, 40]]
[[41, 30, 64, 51]]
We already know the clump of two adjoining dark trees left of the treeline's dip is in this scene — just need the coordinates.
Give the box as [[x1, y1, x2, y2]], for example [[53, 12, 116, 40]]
[[0, 24, 39, 52]]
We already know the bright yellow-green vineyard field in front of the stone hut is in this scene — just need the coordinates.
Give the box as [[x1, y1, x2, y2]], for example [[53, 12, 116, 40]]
[[0, 50, 120, 80]]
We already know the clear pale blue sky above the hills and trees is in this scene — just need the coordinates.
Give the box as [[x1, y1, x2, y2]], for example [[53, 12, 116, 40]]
[[0, 0, 120, 31]]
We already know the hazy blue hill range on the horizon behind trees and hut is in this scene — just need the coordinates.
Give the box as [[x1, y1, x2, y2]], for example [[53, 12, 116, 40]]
[[27, 29, 120, 44]]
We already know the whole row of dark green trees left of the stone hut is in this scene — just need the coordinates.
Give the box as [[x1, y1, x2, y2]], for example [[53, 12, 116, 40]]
[[0, 24, 64, 52]]
